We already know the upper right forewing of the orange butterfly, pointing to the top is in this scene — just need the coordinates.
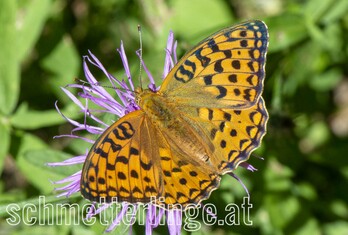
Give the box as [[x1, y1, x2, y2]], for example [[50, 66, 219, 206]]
[[159, 21, 268, 109]]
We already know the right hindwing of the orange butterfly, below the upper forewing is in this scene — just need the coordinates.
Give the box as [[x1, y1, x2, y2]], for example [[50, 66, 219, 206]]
[[173, 97, 268, 174]]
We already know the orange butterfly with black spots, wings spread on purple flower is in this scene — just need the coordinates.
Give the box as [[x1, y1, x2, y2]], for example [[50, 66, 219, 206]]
[[80, 20, 268, 208]]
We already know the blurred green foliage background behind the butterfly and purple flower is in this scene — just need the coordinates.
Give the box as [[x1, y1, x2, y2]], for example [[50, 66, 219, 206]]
[[0, 0, 348, 235]]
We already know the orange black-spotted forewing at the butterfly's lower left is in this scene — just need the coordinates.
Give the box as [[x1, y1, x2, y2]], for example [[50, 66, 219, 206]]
[[80, 110, 163, 202]]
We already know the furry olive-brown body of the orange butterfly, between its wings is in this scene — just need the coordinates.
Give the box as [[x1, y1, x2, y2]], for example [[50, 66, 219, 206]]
[[137, 90, 209, 162]]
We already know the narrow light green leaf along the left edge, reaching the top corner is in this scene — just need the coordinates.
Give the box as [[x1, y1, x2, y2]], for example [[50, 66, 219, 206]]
[[0, 0, 20, 115]]
